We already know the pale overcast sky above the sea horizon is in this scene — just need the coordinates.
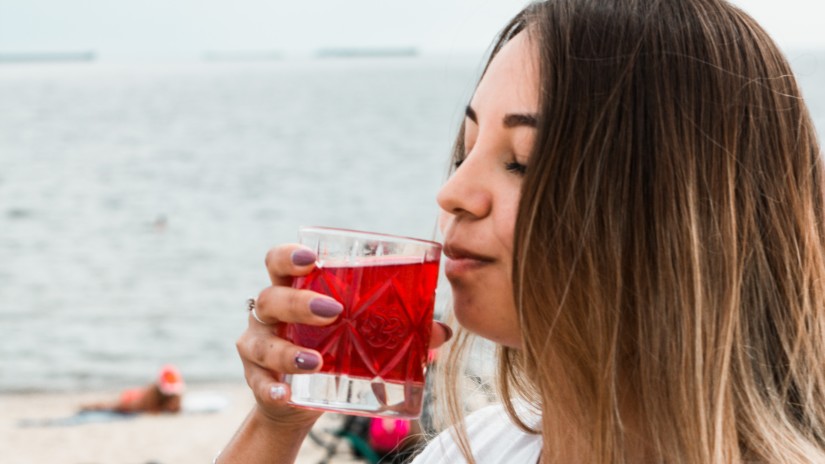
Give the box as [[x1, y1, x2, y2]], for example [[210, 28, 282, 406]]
[[0, 0, 825, 57]]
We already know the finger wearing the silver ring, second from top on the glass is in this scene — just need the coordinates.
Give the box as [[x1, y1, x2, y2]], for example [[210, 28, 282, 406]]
[[255, 287, 344, 325]]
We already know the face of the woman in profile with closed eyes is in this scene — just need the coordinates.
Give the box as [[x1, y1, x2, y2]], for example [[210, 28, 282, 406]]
[[438, 33, 539, 347]]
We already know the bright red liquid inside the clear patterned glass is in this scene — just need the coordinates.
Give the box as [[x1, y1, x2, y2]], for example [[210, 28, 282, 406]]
[[286, 259, 438, 383]]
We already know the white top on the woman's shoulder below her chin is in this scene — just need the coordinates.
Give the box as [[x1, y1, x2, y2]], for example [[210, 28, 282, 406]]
[[412, 404, 542, 464]]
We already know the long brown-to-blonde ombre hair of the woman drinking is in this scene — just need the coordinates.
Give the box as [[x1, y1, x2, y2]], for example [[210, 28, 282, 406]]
[[434, 0, 825, 464]]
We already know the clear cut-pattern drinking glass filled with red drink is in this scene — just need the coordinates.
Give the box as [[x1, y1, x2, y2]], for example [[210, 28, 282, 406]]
[[285, 227, 441, 418]]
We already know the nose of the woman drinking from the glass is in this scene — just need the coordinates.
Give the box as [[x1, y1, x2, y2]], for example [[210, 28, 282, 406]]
[[436, 156, 492, 218]]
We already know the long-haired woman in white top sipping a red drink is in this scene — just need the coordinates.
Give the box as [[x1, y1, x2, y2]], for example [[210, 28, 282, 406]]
[[218, 0, 825, 464]]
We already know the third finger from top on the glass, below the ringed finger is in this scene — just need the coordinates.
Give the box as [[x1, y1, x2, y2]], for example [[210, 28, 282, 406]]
[[235, 323, 323, 376]]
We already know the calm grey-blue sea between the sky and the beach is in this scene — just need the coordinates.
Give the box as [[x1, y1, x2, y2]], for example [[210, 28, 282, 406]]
[[0, 52, 825, 392]]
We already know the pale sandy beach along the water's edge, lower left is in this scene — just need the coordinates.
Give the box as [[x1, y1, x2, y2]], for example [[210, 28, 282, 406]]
[[0, 385, 360, 464]]
